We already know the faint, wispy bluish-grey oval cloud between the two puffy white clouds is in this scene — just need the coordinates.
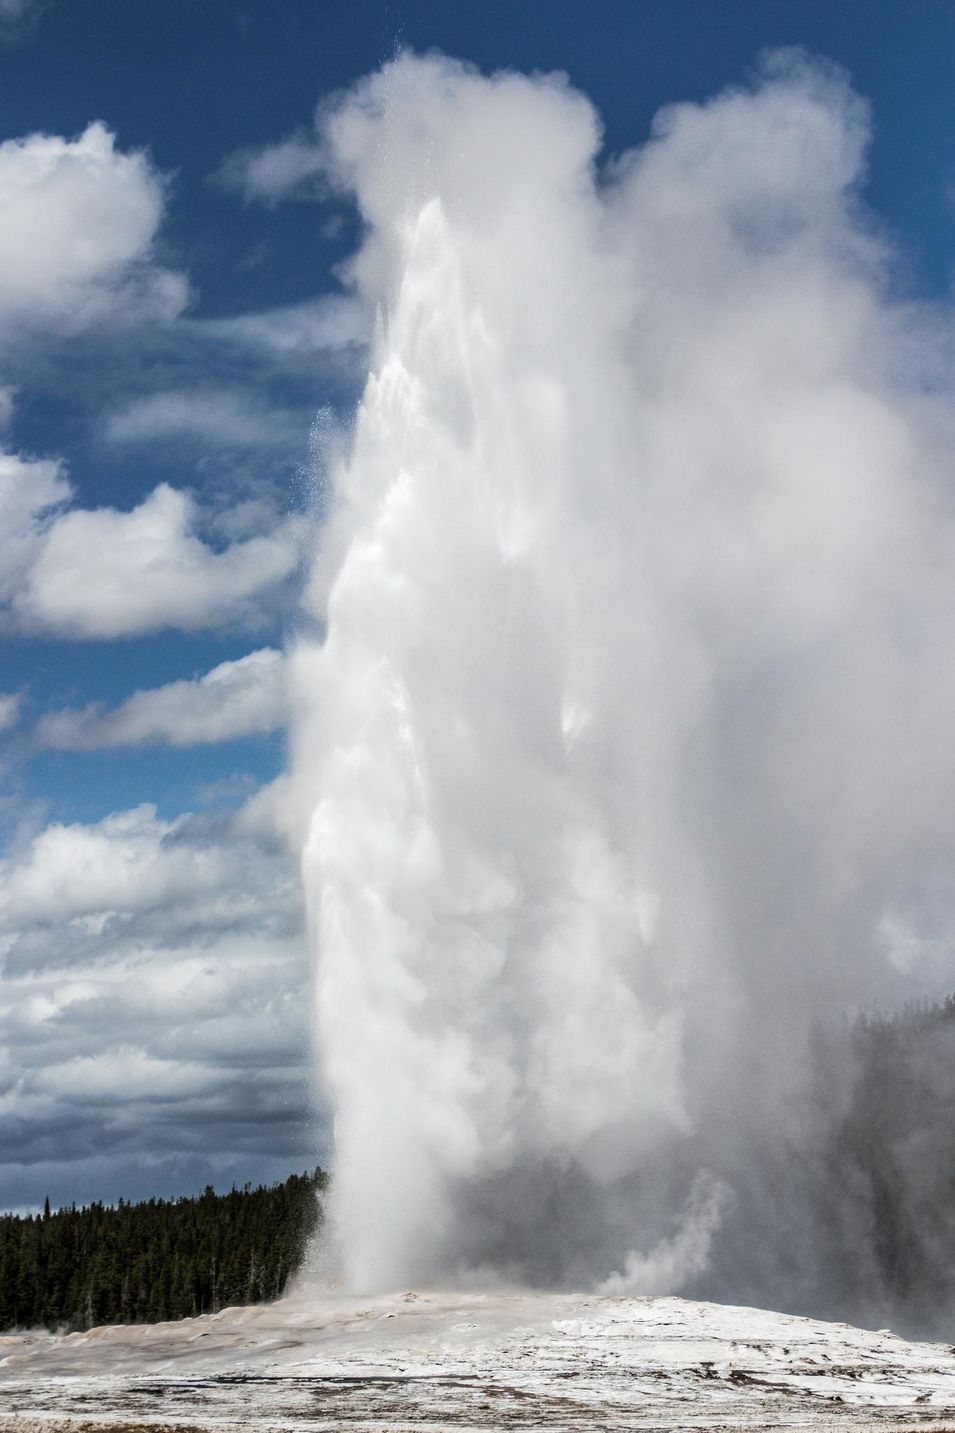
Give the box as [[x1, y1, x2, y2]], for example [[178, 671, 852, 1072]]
[[105, 386, 303, 450]]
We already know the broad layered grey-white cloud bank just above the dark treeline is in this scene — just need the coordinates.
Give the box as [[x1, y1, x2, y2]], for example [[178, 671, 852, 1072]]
[[0, 807, 314, 1204]]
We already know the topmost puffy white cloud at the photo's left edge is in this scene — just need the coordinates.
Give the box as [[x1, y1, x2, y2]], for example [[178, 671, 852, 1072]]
[[0, 123, 186, 331]]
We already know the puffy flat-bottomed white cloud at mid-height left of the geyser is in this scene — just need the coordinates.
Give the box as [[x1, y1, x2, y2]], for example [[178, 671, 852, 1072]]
[[14, 478, 297, 638]]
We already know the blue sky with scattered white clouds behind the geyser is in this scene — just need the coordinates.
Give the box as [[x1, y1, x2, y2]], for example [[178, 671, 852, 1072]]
[[0, 0, 955, 1207]]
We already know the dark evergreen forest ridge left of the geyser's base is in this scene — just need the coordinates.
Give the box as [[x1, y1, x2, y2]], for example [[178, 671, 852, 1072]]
[[0, 1169, 326, 1330]]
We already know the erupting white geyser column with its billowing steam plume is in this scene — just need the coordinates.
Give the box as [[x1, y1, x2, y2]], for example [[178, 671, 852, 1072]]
[[293, 54, 955, 1307]]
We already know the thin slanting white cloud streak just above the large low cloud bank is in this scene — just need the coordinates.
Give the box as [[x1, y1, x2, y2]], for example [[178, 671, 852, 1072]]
[[37, 648, 287, 751]]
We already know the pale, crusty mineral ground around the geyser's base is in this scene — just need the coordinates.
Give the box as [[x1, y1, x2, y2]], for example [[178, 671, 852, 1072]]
[[0, 1291, 955, 1433]]
